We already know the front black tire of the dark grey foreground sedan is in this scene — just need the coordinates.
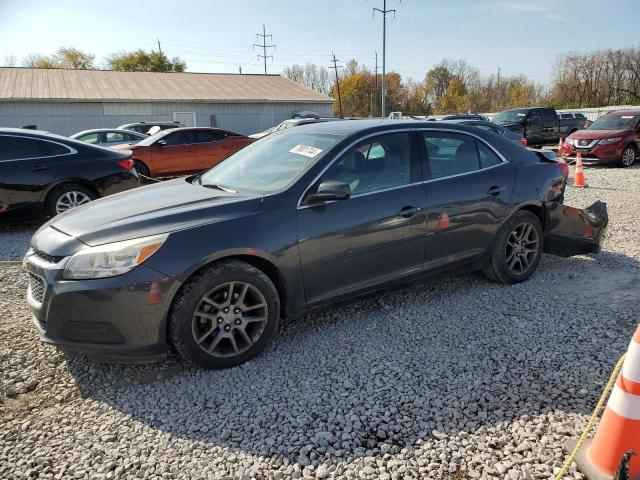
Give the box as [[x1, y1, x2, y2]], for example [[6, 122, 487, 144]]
[[169, 260, 280, 370]]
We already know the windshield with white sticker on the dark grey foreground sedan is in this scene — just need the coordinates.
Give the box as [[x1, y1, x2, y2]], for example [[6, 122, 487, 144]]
[[200, 128, 342, 192]]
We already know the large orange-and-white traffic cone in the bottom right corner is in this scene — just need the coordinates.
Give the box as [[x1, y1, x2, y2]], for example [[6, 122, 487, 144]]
[[576, 325, 640, 480]]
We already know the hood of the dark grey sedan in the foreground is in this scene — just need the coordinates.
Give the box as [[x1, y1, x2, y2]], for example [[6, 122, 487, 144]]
[[43, 178, 262, 246]]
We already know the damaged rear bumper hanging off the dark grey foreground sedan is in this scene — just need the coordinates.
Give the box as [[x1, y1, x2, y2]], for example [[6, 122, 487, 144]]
[[544, 201, 609, 257]]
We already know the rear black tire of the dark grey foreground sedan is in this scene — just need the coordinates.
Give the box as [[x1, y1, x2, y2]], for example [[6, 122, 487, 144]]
[[482, 210, 544, 284]]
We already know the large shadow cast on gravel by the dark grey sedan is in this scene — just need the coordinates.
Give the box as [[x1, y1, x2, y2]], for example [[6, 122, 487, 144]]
[[61, 252, 640, 465]]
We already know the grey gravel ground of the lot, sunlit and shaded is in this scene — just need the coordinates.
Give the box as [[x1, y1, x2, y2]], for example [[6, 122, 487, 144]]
[[0, 163, 640, 480]]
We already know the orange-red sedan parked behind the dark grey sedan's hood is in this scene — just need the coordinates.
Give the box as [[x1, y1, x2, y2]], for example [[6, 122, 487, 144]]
[[114, 127, 254, 177]]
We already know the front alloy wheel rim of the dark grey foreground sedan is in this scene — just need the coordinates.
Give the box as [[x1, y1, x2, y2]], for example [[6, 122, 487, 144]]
[[192, 282, 268, 357]]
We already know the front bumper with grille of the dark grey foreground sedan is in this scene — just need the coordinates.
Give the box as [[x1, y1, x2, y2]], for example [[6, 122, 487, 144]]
[[24, 253, 179, 362]]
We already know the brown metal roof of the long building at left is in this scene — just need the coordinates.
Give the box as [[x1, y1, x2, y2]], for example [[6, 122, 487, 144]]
[[0, 67, 334, 103]]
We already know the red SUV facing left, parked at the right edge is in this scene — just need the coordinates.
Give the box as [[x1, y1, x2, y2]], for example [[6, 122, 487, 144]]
[[560, 110, 640, 167]]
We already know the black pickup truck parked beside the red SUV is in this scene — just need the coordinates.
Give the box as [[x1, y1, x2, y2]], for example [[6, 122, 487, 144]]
[[493, 108, 585, 146]]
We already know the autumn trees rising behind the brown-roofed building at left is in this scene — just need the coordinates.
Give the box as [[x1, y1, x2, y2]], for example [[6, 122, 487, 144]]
[[4, 47, 187, 72]]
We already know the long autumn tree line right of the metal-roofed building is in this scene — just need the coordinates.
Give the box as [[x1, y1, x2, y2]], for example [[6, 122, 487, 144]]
[[282, 47, 640, 117]]
